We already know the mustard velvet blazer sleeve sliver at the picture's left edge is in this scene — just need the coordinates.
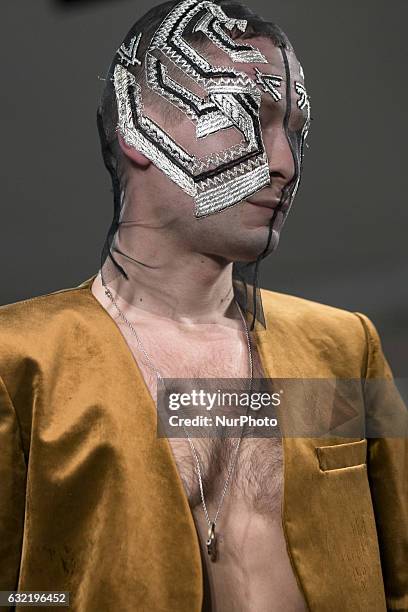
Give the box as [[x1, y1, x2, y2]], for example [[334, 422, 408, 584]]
[[0, 377, 26, 596]]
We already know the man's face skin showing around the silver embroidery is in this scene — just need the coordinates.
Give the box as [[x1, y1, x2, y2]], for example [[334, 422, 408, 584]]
[[129, 38, 309, 261]]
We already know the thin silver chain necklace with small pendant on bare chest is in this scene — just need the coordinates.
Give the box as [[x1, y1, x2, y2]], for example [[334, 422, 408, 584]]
[[102, 279, 254, 561]]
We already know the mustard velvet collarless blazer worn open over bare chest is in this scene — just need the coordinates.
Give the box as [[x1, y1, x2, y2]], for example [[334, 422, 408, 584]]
[[0, 276, 408, 612]]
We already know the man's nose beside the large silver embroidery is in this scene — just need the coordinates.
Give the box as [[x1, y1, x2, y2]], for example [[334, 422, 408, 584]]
[[263, 126, 296, 187]]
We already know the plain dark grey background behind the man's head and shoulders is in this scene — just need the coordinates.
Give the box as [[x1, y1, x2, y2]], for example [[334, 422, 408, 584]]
[[0, 0, 408, 377]]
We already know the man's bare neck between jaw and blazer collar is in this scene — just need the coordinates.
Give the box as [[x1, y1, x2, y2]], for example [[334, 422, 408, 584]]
[[102, 227, 240, 324]]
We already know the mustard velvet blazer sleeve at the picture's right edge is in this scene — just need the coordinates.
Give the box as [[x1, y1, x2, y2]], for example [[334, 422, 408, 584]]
[[355, 313, 408, 612]]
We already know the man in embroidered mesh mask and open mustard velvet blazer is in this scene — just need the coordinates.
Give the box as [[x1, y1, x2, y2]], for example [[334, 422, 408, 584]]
[[0, 0, 408, 612]]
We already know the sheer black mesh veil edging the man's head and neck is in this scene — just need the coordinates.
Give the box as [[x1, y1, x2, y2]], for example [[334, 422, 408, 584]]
[[97, 0, 310, 331]]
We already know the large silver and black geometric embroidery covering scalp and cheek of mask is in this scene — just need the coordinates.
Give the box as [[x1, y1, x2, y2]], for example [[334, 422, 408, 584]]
[[114, 0, 270, 217]]
